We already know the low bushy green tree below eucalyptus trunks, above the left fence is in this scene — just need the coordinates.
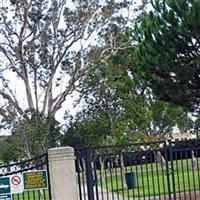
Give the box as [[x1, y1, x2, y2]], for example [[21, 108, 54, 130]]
[[2, 112, 61, 160]]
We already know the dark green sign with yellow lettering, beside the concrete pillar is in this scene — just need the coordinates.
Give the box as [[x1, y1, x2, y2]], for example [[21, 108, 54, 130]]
[[23, 170, 48, 190]]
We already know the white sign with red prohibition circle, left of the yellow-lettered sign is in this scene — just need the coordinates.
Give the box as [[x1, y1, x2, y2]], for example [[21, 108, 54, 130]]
[[10, 174, 24, 194]]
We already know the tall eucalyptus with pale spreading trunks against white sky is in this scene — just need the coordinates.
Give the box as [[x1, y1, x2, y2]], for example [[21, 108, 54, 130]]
[[0, 0, 134, 128]]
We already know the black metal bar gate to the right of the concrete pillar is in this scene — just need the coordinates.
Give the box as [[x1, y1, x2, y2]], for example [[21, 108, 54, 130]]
[[76, 140, 200, 200]]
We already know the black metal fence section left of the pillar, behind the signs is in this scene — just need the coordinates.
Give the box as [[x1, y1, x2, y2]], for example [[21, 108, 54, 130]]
[[0, 153, 51, 200]]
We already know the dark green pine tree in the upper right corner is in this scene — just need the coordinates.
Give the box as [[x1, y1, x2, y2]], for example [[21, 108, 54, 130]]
[[135, 0, 200, 111]]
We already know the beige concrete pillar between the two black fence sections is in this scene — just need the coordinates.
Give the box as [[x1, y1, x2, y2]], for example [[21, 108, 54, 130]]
[[48, 147, 78, 200]]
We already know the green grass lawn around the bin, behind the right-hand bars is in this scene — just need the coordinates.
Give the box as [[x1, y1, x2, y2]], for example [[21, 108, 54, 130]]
[[98, 159, 200, 197]]
